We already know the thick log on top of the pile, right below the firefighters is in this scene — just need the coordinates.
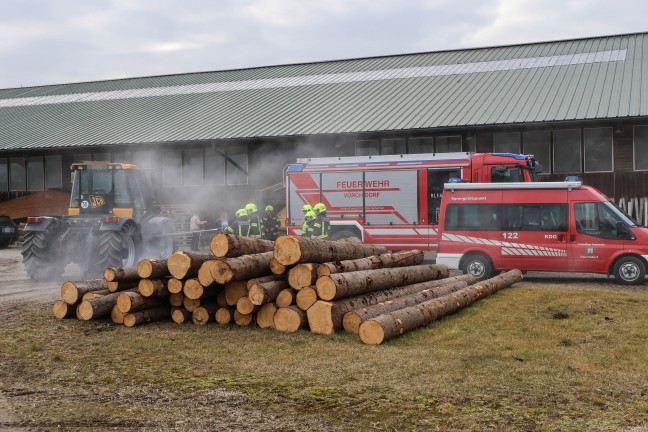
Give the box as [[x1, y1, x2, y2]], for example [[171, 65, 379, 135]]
[[274, 236, 387, 266]]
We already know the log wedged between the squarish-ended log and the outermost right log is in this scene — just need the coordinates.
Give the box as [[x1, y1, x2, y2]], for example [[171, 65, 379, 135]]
[[342, 281, 469, 334]]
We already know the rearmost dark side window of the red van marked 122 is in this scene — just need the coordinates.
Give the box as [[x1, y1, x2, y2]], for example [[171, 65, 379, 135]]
[[444, 204, 501, 231]]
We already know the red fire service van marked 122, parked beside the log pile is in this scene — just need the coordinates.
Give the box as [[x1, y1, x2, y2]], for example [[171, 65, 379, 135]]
[[437, 181, 648, 285]]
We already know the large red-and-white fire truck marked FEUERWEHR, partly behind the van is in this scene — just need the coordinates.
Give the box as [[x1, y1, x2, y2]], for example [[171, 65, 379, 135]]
[[284, 153, 541, 250]]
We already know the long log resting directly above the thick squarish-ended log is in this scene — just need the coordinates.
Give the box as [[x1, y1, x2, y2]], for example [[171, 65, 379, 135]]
[[316, 264, 448, 300]]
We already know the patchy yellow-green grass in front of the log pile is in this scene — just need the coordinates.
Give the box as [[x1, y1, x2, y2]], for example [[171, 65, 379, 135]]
[[0, 279, 648, 431]]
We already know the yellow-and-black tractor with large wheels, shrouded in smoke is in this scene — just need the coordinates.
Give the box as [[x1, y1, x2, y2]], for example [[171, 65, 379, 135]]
[[22, 162, 175, 281]]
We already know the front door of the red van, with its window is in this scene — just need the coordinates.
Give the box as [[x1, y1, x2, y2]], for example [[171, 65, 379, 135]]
[[569, 201, 624, 273]]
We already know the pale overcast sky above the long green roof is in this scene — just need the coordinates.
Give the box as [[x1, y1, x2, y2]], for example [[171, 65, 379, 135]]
[[0, 0, 648, 88]]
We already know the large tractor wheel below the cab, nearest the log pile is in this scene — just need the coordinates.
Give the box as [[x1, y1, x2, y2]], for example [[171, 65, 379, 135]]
[[97, 227, 139, 271]]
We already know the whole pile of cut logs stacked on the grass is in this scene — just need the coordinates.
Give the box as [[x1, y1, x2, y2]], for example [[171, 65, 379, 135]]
[[53, 233, 522, 344]]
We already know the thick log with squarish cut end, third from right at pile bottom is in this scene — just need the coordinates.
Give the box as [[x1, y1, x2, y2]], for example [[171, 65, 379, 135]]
[[302, 275, 476, 334]]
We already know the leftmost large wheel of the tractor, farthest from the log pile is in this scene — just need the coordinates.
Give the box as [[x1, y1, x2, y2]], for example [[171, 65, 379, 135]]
[[21, 226, 65, 282]]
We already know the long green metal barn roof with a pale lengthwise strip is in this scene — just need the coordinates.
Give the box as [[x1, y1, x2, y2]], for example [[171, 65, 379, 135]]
[[0, 33, 648, 150]]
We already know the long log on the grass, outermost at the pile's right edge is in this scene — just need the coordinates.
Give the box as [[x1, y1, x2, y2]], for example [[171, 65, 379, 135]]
[[359, 270, 522, 345]]
